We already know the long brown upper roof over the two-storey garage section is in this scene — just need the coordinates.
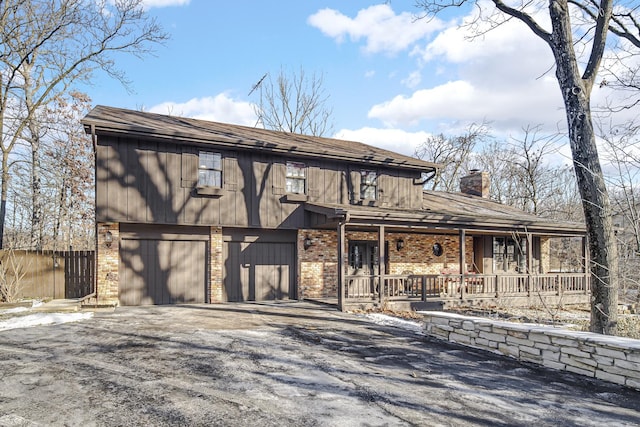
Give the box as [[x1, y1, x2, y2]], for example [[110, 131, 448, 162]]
[[82, 106, 440, 172]]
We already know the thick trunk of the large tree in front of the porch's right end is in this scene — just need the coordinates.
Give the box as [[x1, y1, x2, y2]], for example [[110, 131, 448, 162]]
[[549, 1, 618, 335]]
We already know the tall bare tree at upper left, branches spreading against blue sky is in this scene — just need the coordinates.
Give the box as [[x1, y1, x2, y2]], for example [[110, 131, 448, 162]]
[[0, 0, 167, 251]]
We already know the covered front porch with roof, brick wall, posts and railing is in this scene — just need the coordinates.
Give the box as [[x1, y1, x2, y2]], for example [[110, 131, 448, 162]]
[[299, 193, 591, 310]]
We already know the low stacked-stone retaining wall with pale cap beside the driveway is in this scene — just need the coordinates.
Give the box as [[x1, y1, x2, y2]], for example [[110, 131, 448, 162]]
[[421, 312, 640, 390]]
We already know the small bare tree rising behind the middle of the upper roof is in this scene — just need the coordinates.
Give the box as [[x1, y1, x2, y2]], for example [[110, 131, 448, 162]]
[[251, 68, 332, 136]]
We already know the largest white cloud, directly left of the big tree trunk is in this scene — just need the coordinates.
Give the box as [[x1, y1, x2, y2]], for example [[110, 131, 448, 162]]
[[368, 9, 565, 133]]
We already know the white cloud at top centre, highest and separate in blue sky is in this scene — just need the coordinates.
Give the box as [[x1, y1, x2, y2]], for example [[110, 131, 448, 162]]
[[308, 4, 442, 53]]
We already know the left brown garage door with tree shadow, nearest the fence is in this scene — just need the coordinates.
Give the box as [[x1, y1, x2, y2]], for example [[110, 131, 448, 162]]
[[119, 226, 207, 305]]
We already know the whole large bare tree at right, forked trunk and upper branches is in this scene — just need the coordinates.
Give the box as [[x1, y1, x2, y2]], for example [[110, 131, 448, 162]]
[[417, 0, 640, 334]]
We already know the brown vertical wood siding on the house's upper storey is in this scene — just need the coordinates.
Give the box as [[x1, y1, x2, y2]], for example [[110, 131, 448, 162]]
[[96, 136, 422, 229]]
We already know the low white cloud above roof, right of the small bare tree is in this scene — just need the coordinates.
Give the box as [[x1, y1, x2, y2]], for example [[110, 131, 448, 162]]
[[335, 127, 431, 156]]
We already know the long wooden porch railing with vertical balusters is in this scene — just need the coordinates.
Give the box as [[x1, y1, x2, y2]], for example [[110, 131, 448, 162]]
[[345, 273, 590, 302]]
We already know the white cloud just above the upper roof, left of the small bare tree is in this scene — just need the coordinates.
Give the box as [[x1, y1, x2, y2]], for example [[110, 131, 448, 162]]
[[149, 93, 257, 126]]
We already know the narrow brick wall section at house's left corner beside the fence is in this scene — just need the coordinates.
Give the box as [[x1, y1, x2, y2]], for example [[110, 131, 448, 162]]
[[96, 223, 120, 304]]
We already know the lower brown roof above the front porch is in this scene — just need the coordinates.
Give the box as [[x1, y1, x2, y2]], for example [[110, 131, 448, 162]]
[[305, 191, 586, 235]]
